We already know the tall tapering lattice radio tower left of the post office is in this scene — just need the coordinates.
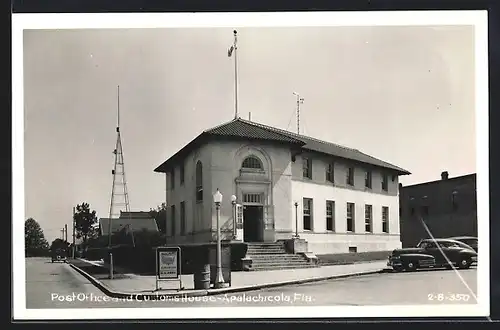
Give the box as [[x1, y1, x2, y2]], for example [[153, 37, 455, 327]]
[[108, 85, 130, 247]]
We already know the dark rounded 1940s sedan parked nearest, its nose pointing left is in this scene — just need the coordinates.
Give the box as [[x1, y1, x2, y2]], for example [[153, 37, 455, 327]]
[[387, 238, 477, 272]]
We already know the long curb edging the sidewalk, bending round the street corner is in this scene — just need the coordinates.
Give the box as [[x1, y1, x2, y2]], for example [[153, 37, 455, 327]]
[[68, 263, 388, 301]]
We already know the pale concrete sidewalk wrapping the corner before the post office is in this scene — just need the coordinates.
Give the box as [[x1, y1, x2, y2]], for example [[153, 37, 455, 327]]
[[70, 259, 386, 299]]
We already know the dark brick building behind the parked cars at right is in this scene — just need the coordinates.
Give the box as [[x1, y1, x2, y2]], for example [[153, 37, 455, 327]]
[[399, 172, 477, 247]]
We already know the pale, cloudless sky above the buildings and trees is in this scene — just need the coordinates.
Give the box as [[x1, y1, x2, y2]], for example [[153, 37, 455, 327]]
[[23, 26, 476, 242]]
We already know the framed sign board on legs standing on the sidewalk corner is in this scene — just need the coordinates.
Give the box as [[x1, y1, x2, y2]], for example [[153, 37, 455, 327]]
[[156, 246, 182, 290]]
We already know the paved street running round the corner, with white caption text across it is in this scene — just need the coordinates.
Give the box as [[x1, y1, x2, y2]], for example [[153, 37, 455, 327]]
[[27, 259, 477, 308]]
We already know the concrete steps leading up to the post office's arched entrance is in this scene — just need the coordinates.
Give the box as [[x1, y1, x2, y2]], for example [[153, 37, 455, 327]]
[[246, 243, 317, 271]]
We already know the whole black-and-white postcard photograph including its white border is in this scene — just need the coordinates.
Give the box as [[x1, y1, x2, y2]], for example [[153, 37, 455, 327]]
[[12, 11, 490, 319]]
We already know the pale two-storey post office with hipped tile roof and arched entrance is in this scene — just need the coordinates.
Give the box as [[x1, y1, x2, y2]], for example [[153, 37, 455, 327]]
[[155, 118, 409, 254]]
